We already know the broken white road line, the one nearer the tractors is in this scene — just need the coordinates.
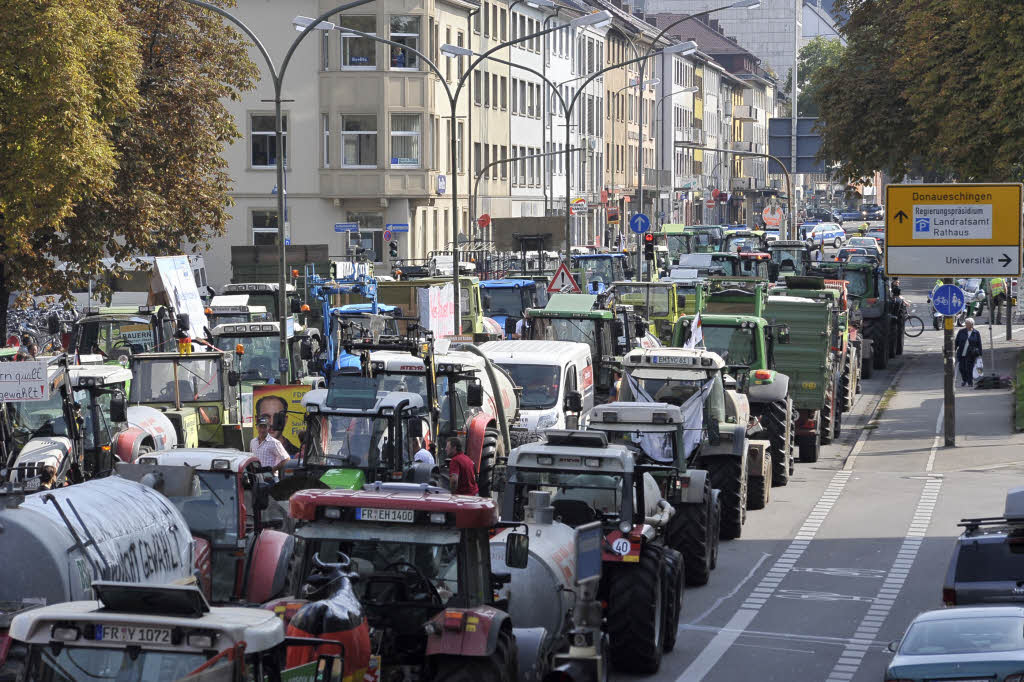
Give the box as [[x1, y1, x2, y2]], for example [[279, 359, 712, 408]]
[[677, 471, 851, 682]]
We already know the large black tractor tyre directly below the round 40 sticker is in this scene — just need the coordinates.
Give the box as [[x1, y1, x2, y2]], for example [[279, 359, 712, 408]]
[[605, 545, 667, 675]]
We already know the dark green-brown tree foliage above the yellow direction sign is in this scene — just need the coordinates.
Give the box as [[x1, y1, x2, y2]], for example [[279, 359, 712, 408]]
[[812, 0, 1024, 181]]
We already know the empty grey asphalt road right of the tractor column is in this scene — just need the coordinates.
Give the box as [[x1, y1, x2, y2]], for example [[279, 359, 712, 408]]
[[612, 270, 1024, 682]]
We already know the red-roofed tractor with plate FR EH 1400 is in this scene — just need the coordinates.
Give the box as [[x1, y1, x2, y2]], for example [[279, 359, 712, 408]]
[[289, 482, 524, 682]]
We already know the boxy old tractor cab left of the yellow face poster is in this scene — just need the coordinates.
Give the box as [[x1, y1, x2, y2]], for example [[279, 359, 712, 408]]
[[128, 349, 246, 450]]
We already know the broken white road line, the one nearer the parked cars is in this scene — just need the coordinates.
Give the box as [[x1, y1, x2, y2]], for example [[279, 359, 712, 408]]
[[825, 474, 942, 682]]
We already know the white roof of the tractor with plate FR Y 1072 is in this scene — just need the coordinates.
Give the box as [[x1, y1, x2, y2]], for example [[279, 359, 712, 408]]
[[9, 601, 285, 651]]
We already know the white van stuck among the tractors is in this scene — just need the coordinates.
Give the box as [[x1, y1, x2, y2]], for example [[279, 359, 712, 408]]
[[480, 340, 594, 432]]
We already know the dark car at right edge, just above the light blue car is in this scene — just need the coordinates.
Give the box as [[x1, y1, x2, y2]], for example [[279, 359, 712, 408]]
[[942, 487, 1024, 606]]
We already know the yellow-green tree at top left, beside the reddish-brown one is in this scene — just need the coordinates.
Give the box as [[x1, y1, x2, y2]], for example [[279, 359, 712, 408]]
[[0, 0, 140, 329]]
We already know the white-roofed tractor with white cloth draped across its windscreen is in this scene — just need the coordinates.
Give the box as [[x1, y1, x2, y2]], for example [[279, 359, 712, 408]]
[[618, 348, 757, 540]]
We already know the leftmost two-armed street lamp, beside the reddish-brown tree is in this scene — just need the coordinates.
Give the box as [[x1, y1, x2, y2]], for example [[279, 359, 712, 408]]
[[183, 0, 373, 385]]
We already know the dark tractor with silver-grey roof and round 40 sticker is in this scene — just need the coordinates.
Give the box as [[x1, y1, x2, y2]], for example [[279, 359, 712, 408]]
[[502, 429, 685, 674]]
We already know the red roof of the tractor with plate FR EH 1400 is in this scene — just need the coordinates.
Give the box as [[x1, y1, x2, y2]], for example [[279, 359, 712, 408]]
[[289, 483, 498, 528]]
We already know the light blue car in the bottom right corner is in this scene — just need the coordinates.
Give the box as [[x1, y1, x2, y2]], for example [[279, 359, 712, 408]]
[[885, 606, 1024, 682]]
